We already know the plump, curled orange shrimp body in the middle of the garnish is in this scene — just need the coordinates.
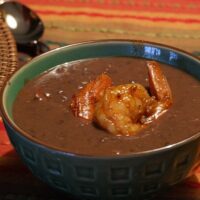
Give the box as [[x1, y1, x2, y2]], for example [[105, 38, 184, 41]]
[[94, 83, 150, 136]]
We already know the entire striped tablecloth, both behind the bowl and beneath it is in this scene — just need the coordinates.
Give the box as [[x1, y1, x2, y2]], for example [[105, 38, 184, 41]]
[[0, 0, 200, 200]]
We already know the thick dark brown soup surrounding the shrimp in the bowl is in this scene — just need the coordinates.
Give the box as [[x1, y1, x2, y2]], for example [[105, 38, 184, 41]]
[[13, 57, 200, 155]]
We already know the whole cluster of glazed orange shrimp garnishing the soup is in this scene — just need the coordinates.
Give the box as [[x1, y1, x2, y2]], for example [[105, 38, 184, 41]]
[[71, 61, 172, 136]]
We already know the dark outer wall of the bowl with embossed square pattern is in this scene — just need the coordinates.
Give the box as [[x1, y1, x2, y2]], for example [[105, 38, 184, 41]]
[[2, 118, 200, 200]]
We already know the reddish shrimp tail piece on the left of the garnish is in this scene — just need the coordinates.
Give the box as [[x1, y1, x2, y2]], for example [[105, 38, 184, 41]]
[[70, 74, 112, 121]]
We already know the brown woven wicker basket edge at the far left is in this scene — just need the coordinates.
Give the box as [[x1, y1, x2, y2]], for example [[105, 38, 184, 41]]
[[0, 12, 18, 90]]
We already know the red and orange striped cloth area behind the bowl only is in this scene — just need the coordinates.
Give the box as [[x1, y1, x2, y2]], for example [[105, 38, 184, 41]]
[[18, 0, 200, 52]]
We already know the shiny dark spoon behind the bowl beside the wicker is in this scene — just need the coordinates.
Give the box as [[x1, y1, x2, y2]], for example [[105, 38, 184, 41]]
[[0, 0, 49, 56]]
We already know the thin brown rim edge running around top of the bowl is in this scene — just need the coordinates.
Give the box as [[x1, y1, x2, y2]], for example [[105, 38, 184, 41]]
[[0, 39, 200, 159]]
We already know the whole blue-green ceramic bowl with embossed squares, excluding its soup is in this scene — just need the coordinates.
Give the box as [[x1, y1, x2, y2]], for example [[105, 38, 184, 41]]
[[1, 40, 200, 200]]
